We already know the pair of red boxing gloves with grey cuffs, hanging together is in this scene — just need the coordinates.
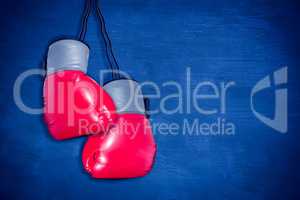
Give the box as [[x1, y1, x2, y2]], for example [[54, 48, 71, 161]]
[[43, 40, 156, 179]]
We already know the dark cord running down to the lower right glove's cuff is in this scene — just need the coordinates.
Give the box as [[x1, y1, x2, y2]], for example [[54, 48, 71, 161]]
[[94, 0, 121, 79]]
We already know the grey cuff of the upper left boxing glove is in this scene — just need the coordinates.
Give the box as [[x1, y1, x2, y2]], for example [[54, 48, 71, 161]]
[[47, 39, 89, 74]]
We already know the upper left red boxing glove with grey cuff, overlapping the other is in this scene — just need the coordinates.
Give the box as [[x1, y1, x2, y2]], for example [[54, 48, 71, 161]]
[[43, 40, 117, 140]]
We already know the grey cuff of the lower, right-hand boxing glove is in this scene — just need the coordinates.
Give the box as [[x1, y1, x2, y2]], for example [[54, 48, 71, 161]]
[[103, 79, 145, 114]]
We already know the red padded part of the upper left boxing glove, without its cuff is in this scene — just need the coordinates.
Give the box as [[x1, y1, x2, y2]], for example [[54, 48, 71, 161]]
[[44, 70, 117, 140]]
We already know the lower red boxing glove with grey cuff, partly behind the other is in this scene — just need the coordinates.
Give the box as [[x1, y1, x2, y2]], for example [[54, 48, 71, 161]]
[[82, 79, 156, 179]]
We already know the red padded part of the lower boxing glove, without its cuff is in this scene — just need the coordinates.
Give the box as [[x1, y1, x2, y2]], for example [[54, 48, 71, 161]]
[[82, 113, 156, 179]]
